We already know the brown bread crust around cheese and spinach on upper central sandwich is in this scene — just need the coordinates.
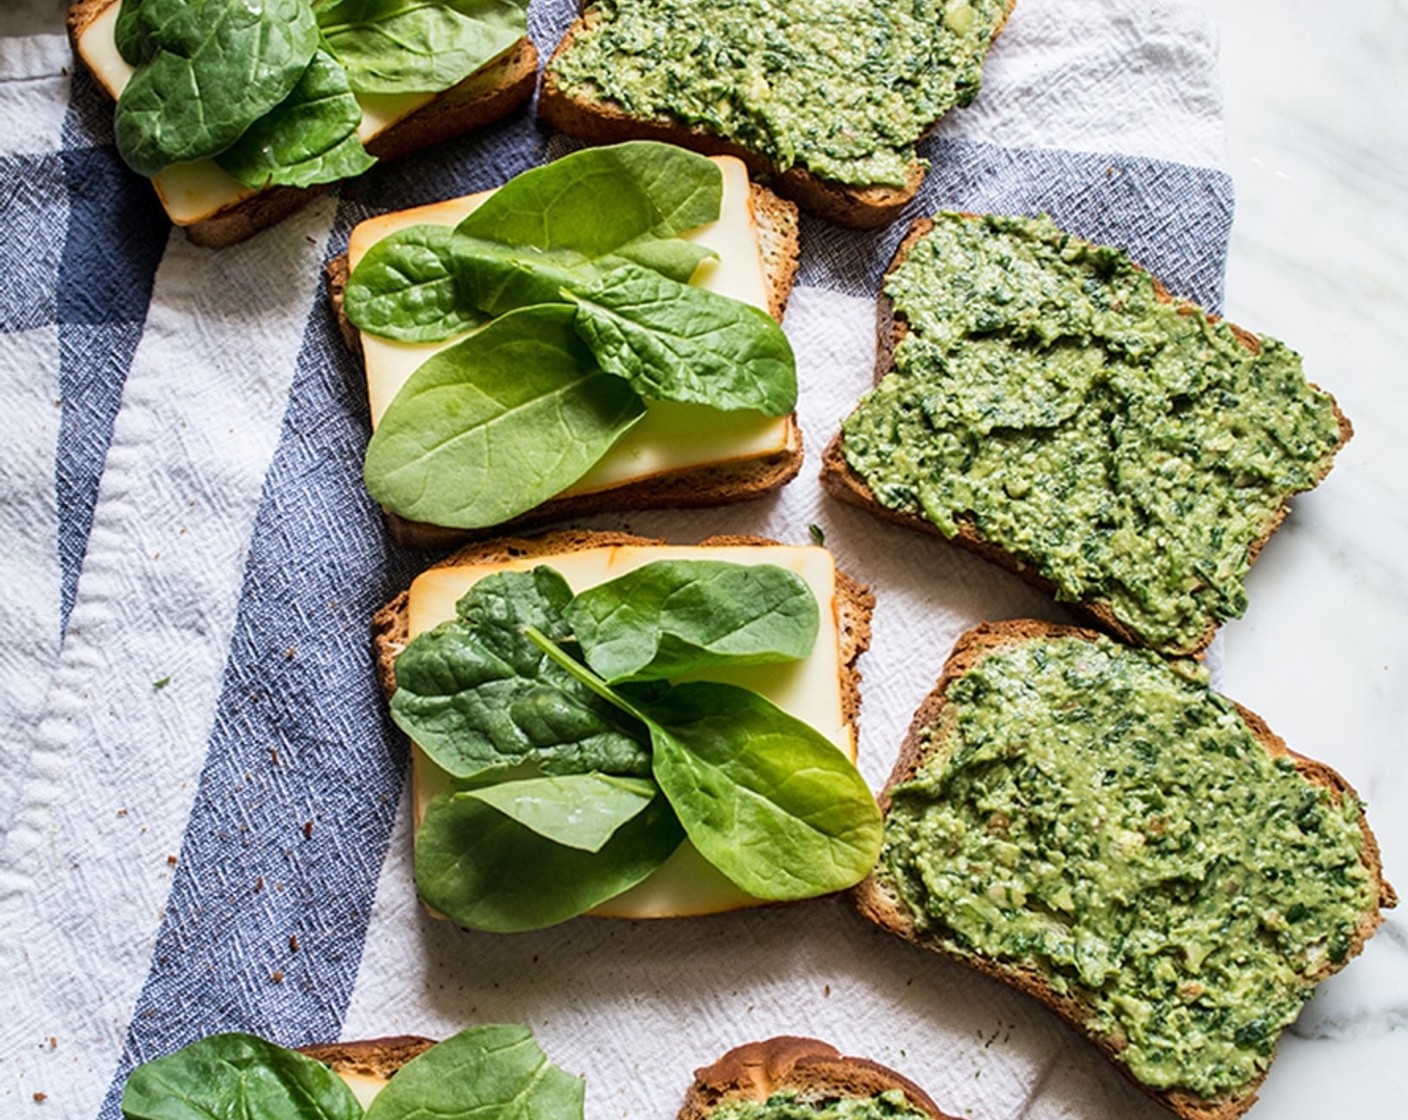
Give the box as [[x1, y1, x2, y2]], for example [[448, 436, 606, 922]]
[[327, 175, 804, 551]]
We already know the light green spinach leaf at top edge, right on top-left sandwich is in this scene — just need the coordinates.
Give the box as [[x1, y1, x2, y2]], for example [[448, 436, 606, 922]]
[[315, 0, 528, 93]]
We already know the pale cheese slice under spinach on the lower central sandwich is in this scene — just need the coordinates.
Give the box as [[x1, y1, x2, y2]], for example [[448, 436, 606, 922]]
[[407, 545, 856, 919]]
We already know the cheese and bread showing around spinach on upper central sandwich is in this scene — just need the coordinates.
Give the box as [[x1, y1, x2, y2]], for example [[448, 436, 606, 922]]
[[329, 158, 803, 548]]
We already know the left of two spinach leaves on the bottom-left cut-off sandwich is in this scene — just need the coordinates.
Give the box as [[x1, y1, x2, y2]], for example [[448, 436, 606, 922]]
[[121, 1034, 362, 1120]]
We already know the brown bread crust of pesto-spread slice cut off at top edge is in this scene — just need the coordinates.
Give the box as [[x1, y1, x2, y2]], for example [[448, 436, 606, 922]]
[[538, 0, 1017, 230]]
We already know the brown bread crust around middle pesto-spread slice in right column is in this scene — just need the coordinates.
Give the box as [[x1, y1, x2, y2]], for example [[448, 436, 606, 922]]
[[821, 214, 1353, 655]]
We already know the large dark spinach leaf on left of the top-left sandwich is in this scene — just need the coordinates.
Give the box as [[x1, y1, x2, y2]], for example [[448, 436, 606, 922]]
[[114, 0, 318, 175]]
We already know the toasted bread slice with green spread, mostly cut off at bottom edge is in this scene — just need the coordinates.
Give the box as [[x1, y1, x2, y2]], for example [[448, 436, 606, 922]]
[[679, 1035, 953, 1120]]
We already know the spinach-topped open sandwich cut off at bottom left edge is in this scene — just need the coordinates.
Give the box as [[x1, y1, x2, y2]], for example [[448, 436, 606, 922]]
[[121, 1026, 584, 1120]]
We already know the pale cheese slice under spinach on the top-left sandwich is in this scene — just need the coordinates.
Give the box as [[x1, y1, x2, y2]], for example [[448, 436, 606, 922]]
[[76, 0, 501, 225]]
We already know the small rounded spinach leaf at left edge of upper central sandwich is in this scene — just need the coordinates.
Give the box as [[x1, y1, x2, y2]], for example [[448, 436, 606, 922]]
[[342, 225, 489, 342]]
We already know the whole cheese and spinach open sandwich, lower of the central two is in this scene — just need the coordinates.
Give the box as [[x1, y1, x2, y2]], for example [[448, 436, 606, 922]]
[[375, 531, 880, 933]]
